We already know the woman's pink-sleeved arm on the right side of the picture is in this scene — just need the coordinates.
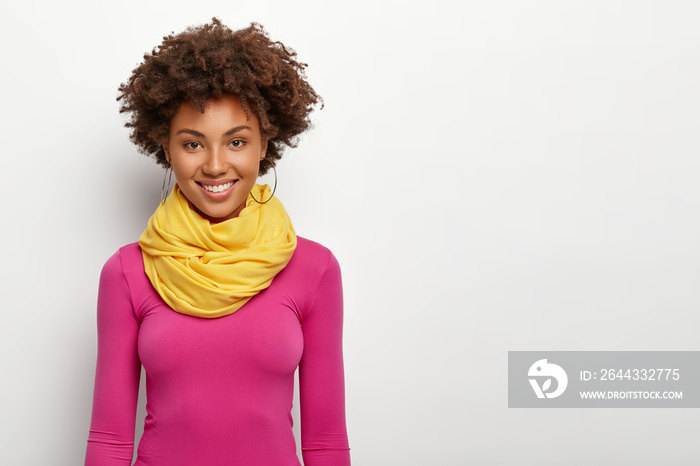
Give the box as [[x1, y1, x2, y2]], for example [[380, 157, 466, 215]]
[[299, 253, 350, 466]]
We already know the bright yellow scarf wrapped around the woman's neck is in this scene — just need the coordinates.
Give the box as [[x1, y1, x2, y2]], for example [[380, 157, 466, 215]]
[[139, 184, 297, 318]]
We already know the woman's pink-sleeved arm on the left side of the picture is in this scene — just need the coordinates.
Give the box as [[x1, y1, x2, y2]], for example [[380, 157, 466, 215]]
[[85, 253, 141, 466]]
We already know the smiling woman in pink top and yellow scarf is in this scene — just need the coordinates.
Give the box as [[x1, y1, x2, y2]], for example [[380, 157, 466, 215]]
[[86, 18, 350, 466]]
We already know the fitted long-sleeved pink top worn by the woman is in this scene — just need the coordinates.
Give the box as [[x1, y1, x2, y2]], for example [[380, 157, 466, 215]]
[[85, 238, 350, 466]]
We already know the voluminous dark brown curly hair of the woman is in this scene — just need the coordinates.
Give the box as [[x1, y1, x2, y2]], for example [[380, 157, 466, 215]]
[[117, 18, 323, 175]]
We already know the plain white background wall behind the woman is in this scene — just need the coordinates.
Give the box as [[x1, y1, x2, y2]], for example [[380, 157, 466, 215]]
[[0, 0, 700, 466]]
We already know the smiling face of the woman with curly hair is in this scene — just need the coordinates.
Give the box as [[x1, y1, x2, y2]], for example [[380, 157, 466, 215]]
[[164, 95, 267, 220]]
